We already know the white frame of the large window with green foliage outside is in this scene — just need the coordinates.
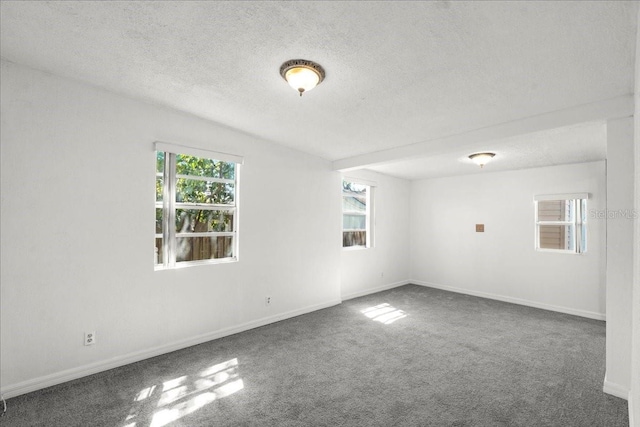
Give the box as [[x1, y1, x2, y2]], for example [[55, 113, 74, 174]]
[[154, 142, 244, 270]]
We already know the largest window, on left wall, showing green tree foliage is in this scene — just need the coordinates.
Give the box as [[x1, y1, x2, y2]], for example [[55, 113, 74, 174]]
[[155, 143, 242, 268]]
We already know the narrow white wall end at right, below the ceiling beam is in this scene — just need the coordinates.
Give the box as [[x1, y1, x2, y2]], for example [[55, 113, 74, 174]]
[[604, 117, 634, 399]]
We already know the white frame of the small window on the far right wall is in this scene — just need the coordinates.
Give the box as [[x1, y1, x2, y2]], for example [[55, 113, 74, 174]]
[[533, 193, 589, 254]]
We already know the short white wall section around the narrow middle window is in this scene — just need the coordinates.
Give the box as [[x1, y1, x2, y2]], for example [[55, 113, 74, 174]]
[[340, 170, 410, 299]]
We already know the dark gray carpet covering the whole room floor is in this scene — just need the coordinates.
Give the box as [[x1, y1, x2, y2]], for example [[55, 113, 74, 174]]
[[0, 285, 628, 427]]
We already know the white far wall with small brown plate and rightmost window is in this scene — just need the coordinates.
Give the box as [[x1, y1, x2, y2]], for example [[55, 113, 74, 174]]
[[410, 162, 606, 319]]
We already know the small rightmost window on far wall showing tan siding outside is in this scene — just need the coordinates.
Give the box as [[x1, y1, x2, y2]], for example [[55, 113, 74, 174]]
[[534, 194, 589, 254]]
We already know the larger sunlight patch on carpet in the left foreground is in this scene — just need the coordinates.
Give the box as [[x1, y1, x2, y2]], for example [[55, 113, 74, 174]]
[[125, 358, 244, 427]]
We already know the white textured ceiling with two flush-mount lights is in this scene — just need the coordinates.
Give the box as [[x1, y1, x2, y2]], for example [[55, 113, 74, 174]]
[[0, 1, 638, 179]]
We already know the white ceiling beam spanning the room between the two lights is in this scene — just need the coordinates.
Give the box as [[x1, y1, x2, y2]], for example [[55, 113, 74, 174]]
[[332, 95, 634, 171]]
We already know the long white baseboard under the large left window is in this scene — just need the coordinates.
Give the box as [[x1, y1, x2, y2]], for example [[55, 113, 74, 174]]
[[0, 300, 341, 399]]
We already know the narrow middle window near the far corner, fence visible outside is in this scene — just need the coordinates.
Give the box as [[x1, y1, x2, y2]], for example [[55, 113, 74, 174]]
[[342, 180, 372, 248]]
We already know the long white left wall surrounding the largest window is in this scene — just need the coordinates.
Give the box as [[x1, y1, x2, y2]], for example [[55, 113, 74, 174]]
[[0, 61, 341, 397]]
